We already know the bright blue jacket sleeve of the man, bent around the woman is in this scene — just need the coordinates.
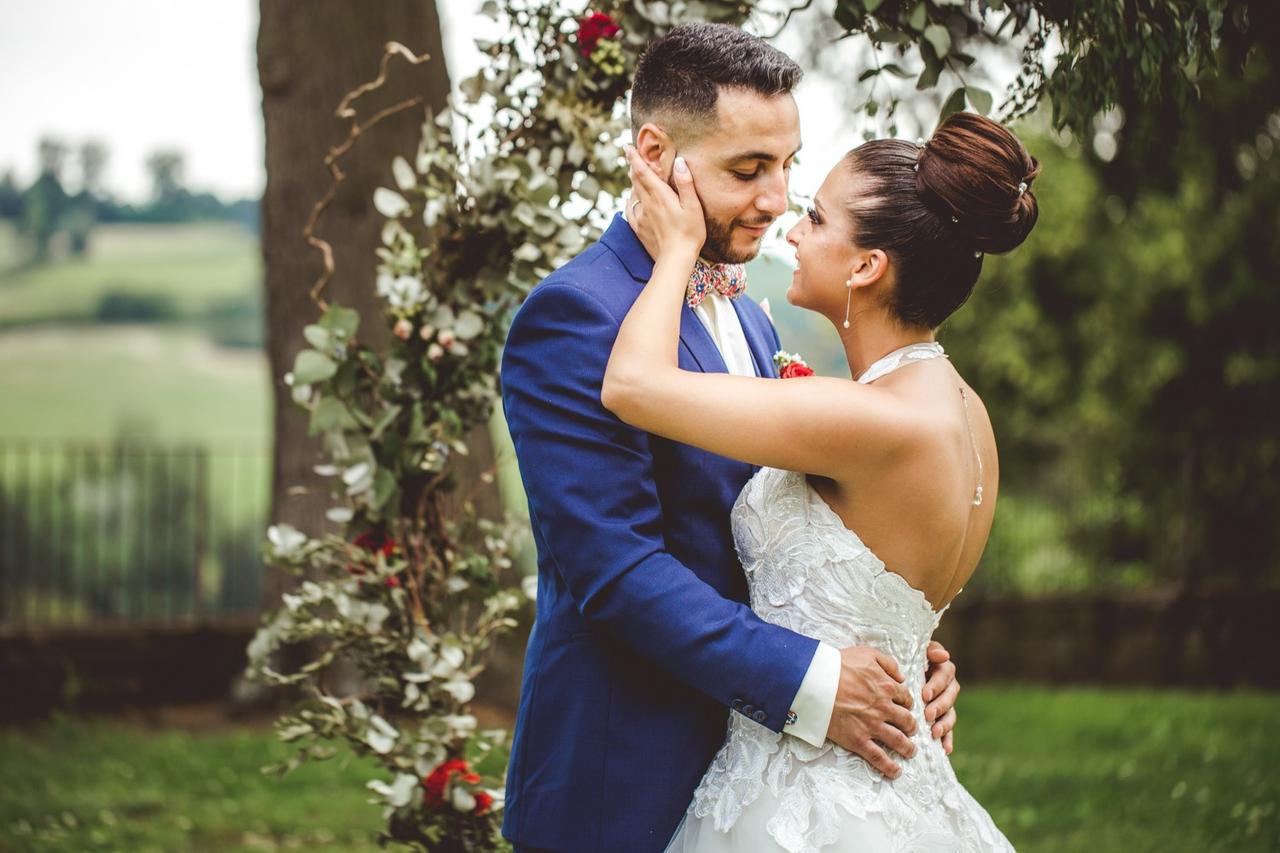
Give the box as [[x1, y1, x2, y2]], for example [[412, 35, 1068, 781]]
[[502, 283, 817, 731]]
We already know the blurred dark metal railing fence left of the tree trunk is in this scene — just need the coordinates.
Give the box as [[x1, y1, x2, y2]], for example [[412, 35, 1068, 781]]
[[0, 439, 270, 629]]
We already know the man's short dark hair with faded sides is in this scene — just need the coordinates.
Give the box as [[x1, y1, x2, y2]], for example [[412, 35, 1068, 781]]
[[631, 23, 804, 136]]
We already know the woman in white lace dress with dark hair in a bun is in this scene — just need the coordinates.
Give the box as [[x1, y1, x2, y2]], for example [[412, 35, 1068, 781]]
[[602, 113, 1039, 853]]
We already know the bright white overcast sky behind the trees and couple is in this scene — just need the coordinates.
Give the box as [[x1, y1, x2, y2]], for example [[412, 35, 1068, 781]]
[[0, 0, 942, 200]]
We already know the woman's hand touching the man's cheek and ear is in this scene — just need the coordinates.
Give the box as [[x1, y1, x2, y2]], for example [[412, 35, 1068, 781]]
[[625, 146, 707, 261]]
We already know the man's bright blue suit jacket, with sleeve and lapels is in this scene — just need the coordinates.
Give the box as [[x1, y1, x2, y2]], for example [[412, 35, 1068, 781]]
[[502, 216, 817, 853]]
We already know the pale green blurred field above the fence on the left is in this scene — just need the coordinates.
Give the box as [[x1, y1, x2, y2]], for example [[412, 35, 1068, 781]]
[[0, 223, 270, 443]]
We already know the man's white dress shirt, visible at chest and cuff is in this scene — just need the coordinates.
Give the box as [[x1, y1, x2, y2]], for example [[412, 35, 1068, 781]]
[[694, 291, 840, 747]]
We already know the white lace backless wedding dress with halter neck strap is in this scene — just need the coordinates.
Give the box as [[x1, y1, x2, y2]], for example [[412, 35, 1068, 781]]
[[667, 345, 1014, 853]]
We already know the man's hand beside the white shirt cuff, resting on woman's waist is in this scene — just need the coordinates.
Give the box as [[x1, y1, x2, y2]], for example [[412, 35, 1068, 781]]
[[827, 646, 915, 779]]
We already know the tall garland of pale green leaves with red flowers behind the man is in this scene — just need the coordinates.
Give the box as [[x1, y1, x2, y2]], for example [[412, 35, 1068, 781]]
[[250, 0, 744, 850]]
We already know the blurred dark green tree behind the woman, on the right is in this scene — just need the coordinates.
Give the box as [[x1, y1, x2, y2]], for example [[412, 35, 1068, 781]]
[[941, 45, 1280, 589]]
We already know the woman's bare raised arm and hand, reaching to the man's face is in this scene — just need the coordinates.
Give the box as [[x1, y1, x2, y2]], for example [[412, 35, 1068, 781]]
[[602, 150, 923, 479]]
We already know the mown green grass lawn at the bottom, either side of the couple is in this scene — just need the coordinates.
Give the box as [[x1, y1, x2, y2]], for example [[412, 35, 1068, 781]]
[[0, 686, 1280, 853]]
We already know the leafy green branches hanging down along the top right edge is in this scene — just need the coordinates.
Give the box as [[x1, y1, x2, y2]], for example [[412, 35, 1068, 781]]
[[835, 0, 1268, 136]]
